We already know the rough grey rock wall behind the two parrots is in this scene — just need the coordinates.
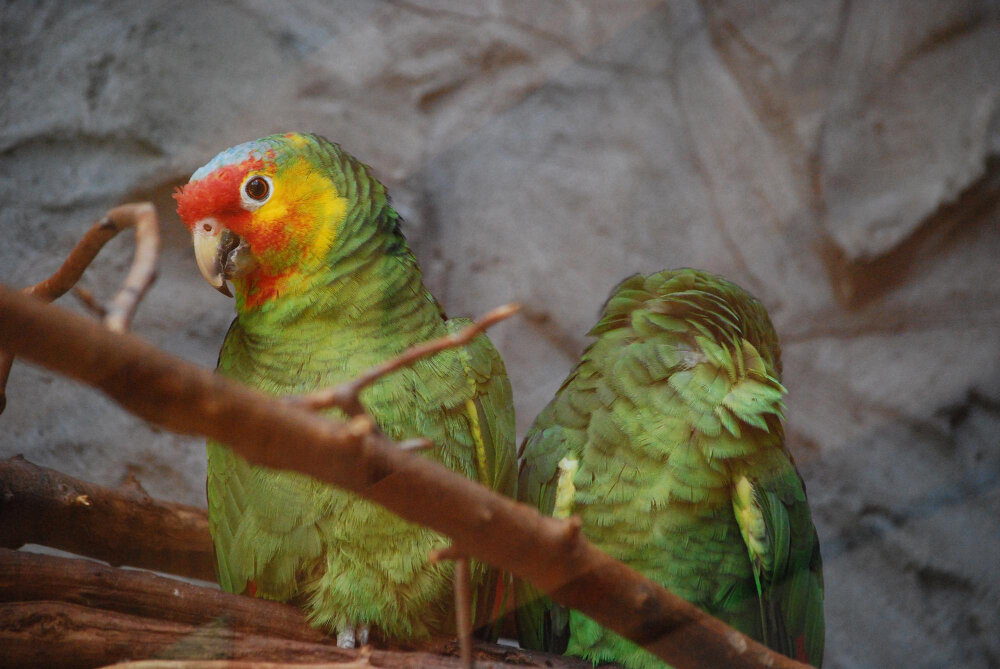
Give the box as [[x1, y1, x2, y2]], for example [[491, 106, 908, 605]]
[[0, 0, 1000, 667]]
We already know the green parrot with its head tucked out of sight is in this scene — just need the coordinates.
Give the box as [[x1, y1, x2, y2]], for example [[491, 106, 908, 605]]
[[515, 269, 824, 667]]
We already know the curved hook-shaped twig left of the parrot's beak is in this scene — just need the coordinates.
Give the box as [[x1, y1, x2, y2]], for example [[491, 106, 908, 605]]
[[0, 202, 160, 413]]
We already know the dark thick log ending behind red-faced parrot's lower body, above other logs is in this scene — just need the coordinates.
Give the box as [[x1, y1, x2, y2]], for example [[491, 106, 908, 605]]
[[0, 457, 215, 581]]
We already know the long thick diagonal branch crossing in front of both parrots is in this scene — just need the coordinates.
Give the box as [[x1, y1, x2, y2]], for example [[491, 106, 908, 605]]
[[0, 286, 805, 669]]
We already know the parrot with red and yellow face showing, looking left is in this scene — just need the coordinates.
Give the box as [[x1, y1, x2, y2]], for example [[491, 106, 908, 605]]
[[174, 133, 517, 647]]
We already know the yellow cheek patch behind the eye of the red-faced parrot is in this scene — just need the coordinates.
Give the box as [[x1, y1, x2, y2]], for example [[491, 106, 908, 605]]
[[252, 160, 347, 261]]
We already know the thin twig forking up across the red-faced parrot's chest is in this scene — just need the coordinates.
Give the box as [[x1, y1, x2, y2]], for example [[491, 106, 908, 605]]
[[287, 302, 521, 416]]
